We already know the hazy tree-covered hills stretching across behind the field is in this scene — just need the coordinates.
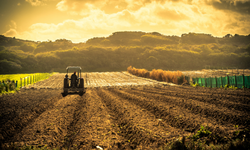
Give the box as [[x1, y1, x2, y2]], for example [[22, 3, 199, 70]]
[[0, 32, 250, 74]]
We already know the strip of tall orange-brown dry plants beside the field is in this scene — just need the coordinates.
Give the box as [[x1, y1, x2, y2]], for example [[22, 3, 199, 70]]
[[127, 66, 187, 84]]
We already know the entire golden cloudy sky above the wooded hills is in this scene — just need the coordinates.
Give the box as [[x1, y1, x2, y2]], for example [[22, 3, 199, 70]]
[[0, 0, 250, 43]]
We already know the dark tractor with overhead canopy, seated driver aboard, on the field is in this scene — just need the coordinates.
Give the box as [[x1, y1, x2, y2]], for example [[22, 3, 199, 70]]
[[63, 66, 85, 96]]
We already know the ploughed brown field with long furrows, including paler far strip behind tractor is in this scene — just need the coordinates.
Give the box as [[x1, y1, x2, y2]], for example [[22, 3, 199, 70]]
[[0, 73, 250, 149]]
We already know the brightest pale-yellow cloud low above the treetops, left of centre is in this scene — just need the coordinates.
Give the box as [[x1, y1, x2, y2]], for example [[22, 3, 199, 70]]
[[15, 10, 134, 42]]
